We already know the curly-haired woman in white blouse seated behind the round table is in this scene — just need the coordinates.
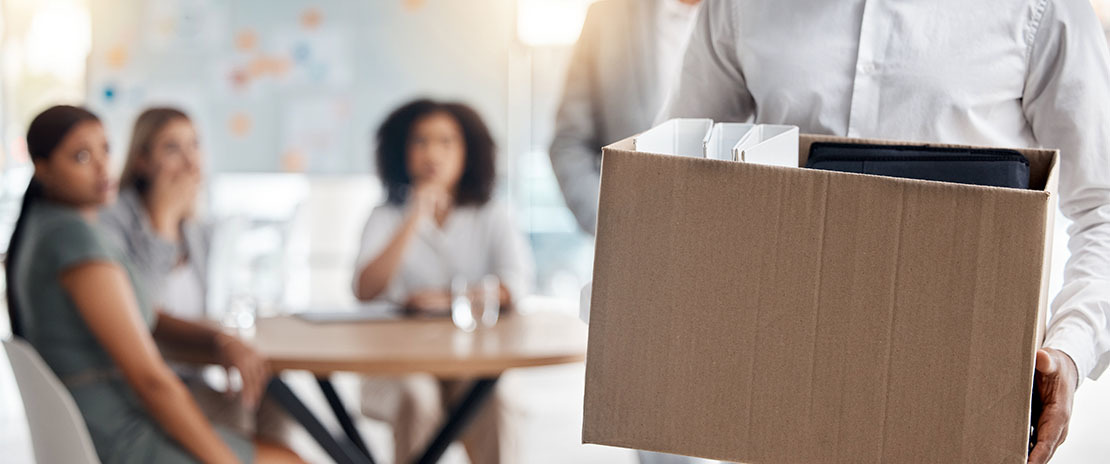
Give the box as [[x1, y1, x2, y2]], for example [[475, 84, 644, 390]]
[[354, 100, 533, 464]]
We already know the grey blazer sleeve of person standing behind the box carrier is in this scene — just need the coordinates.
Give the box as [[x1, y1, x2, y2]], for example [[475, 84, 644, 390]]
[[548, 4, 602, 234]]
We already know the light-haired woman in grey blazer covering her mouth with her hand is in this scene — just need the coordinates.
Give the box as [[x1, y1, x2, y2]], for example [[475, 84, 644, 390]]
[[100, 108, 290, 443]]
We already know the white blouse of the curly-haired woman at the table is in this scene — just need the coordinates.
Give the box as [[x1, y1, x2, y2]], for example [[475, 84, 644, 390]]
[[353, 201, 534, 303]]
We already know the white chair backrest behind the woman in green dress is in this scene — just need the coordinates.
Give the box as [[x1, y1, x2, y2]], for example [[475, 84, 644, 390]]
[[3, 339, 100, 464]]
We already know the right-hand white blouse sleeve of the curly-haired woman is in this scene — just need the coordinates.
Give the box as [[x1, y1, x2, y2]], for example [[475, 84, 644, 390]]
[[490, 203, 535, 303]]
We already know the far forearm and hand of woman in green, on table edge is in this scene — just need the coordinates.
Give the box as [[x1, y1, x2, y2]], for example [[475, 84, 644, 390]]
[[153, 312, 271, 407]]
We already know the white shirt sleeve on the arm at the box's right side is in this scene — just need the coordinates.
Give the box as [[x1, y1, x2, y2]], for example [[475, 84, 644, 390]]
[[1022, 0, 1110, 379]]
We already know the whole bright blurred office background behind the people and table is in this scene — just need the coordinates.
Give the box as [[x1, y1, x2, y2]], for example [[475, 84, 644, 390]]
[[0, 0, 1110, 463]]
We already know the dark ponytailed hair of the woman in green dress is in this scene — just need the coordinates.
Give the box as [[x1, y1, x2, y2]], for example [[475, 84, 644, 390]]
[[4, 105, 100, 336]]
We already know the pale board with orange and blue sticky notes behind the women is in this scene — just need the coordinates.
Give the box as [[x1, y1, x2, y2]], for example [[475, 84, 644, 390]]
[[88, 0, 515, 174]]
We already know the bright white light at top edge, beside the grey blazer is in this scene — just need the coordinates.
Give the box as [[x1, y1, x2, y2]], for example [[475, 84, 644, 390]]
[[516, 0, 593, 47]]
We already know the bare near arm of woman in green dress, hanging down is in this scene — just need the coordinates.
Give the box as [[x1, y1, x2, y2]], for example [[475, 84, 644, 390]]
[[61, 261, 238, 463]]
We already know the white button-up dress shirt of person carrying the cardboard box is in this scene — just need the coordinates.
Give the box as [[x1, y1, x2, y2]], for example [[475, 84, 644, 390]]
[[659, 0, 1110, 379]]
